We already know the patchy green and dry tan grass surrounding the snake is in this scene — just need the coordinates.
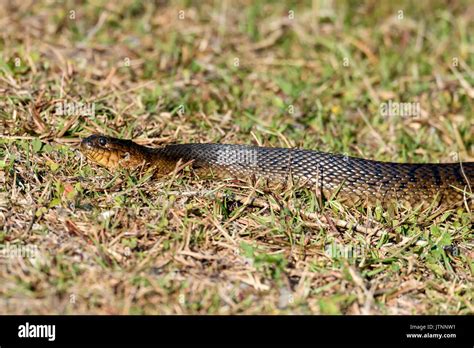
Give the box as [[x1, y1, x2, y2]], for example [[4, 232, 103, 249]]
[[0, 1, 474, 314]]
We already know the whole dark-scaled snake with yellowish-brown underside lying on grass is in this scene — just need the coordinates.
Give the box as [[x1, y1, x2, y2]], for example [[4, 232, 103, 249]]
[[80, 134, 474, 210]]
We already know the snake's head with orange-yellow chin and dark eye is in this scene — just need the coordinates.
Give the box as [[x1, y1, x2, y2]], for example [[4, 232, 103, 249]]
[[80, 134, 149, 169]]
